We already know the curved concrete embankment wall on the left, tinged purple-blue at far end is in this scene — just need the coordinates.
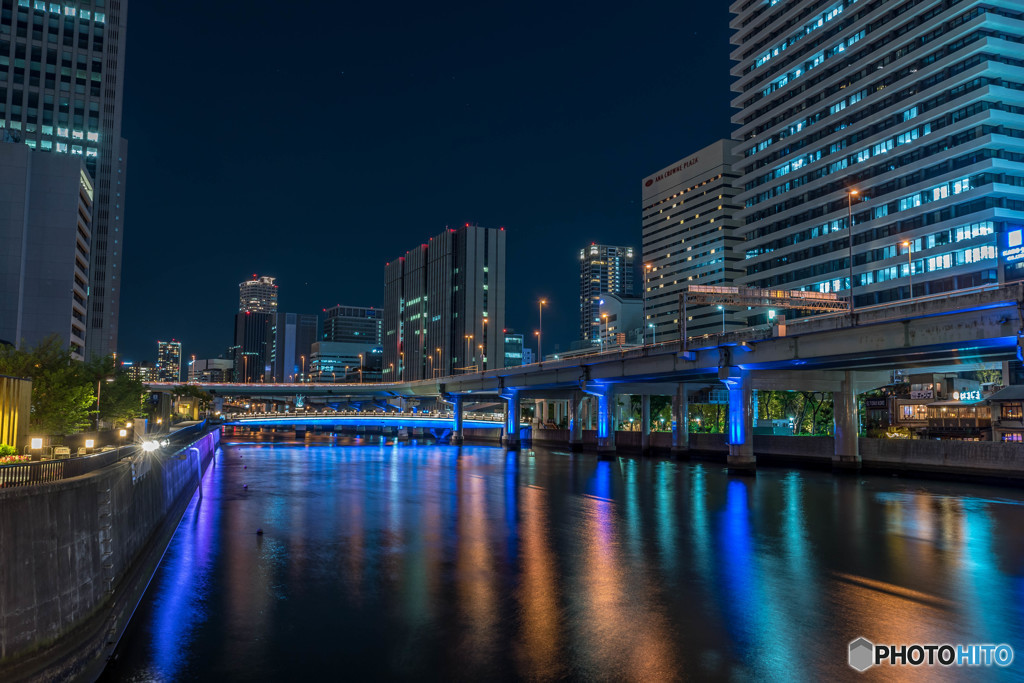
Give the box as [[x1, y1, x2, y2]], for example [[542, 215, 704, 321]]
[[0, 429, 220, 681]]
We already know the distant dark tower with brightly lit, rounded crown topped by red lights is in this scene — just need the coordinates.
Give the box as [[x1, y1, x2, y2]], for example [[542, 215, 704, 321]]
[[232, 275, 278, 382]]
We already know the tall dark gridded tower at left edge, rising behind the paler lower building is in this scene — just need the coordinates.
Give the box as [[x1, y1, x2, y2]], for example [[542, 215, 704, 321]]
[[0, 0, 128, 356]]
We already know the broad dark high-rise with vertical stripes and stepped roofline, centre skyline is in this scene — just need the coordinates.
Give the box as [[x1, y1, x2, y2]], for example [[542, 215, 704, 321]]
[[383, 223, 506, 382]]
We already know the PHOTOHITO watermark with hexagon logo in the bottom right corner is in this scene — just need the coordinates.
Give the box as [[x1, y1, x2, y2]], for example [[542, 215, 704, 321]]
[[849, 638, 1014, 672]]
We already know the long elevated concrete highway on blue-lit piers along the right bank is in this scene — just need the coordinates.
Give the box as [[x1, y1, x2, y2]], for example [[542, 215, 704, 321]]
[[147, 284, 1024, 470]]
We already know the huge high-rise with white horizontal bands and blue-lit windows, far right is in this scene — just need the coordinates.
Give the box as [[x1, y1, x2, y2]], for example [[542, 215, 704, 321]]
[[731, 0, 1024, 323]]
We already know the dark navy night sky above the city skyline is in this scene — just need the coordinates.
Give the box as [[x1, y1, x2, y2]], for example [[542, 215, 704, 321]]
[[119, 0, 731, 360]]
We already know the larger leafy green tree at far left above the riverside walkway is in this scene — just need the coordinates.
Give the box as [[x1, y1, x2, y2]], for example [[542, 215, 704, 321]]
[[0, 335, 96, 436]]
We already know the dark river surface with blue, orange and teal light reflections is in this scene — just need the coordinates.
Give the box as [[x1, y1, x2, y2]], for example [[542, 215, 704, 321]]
[[104, 441, 1024, 681]]
